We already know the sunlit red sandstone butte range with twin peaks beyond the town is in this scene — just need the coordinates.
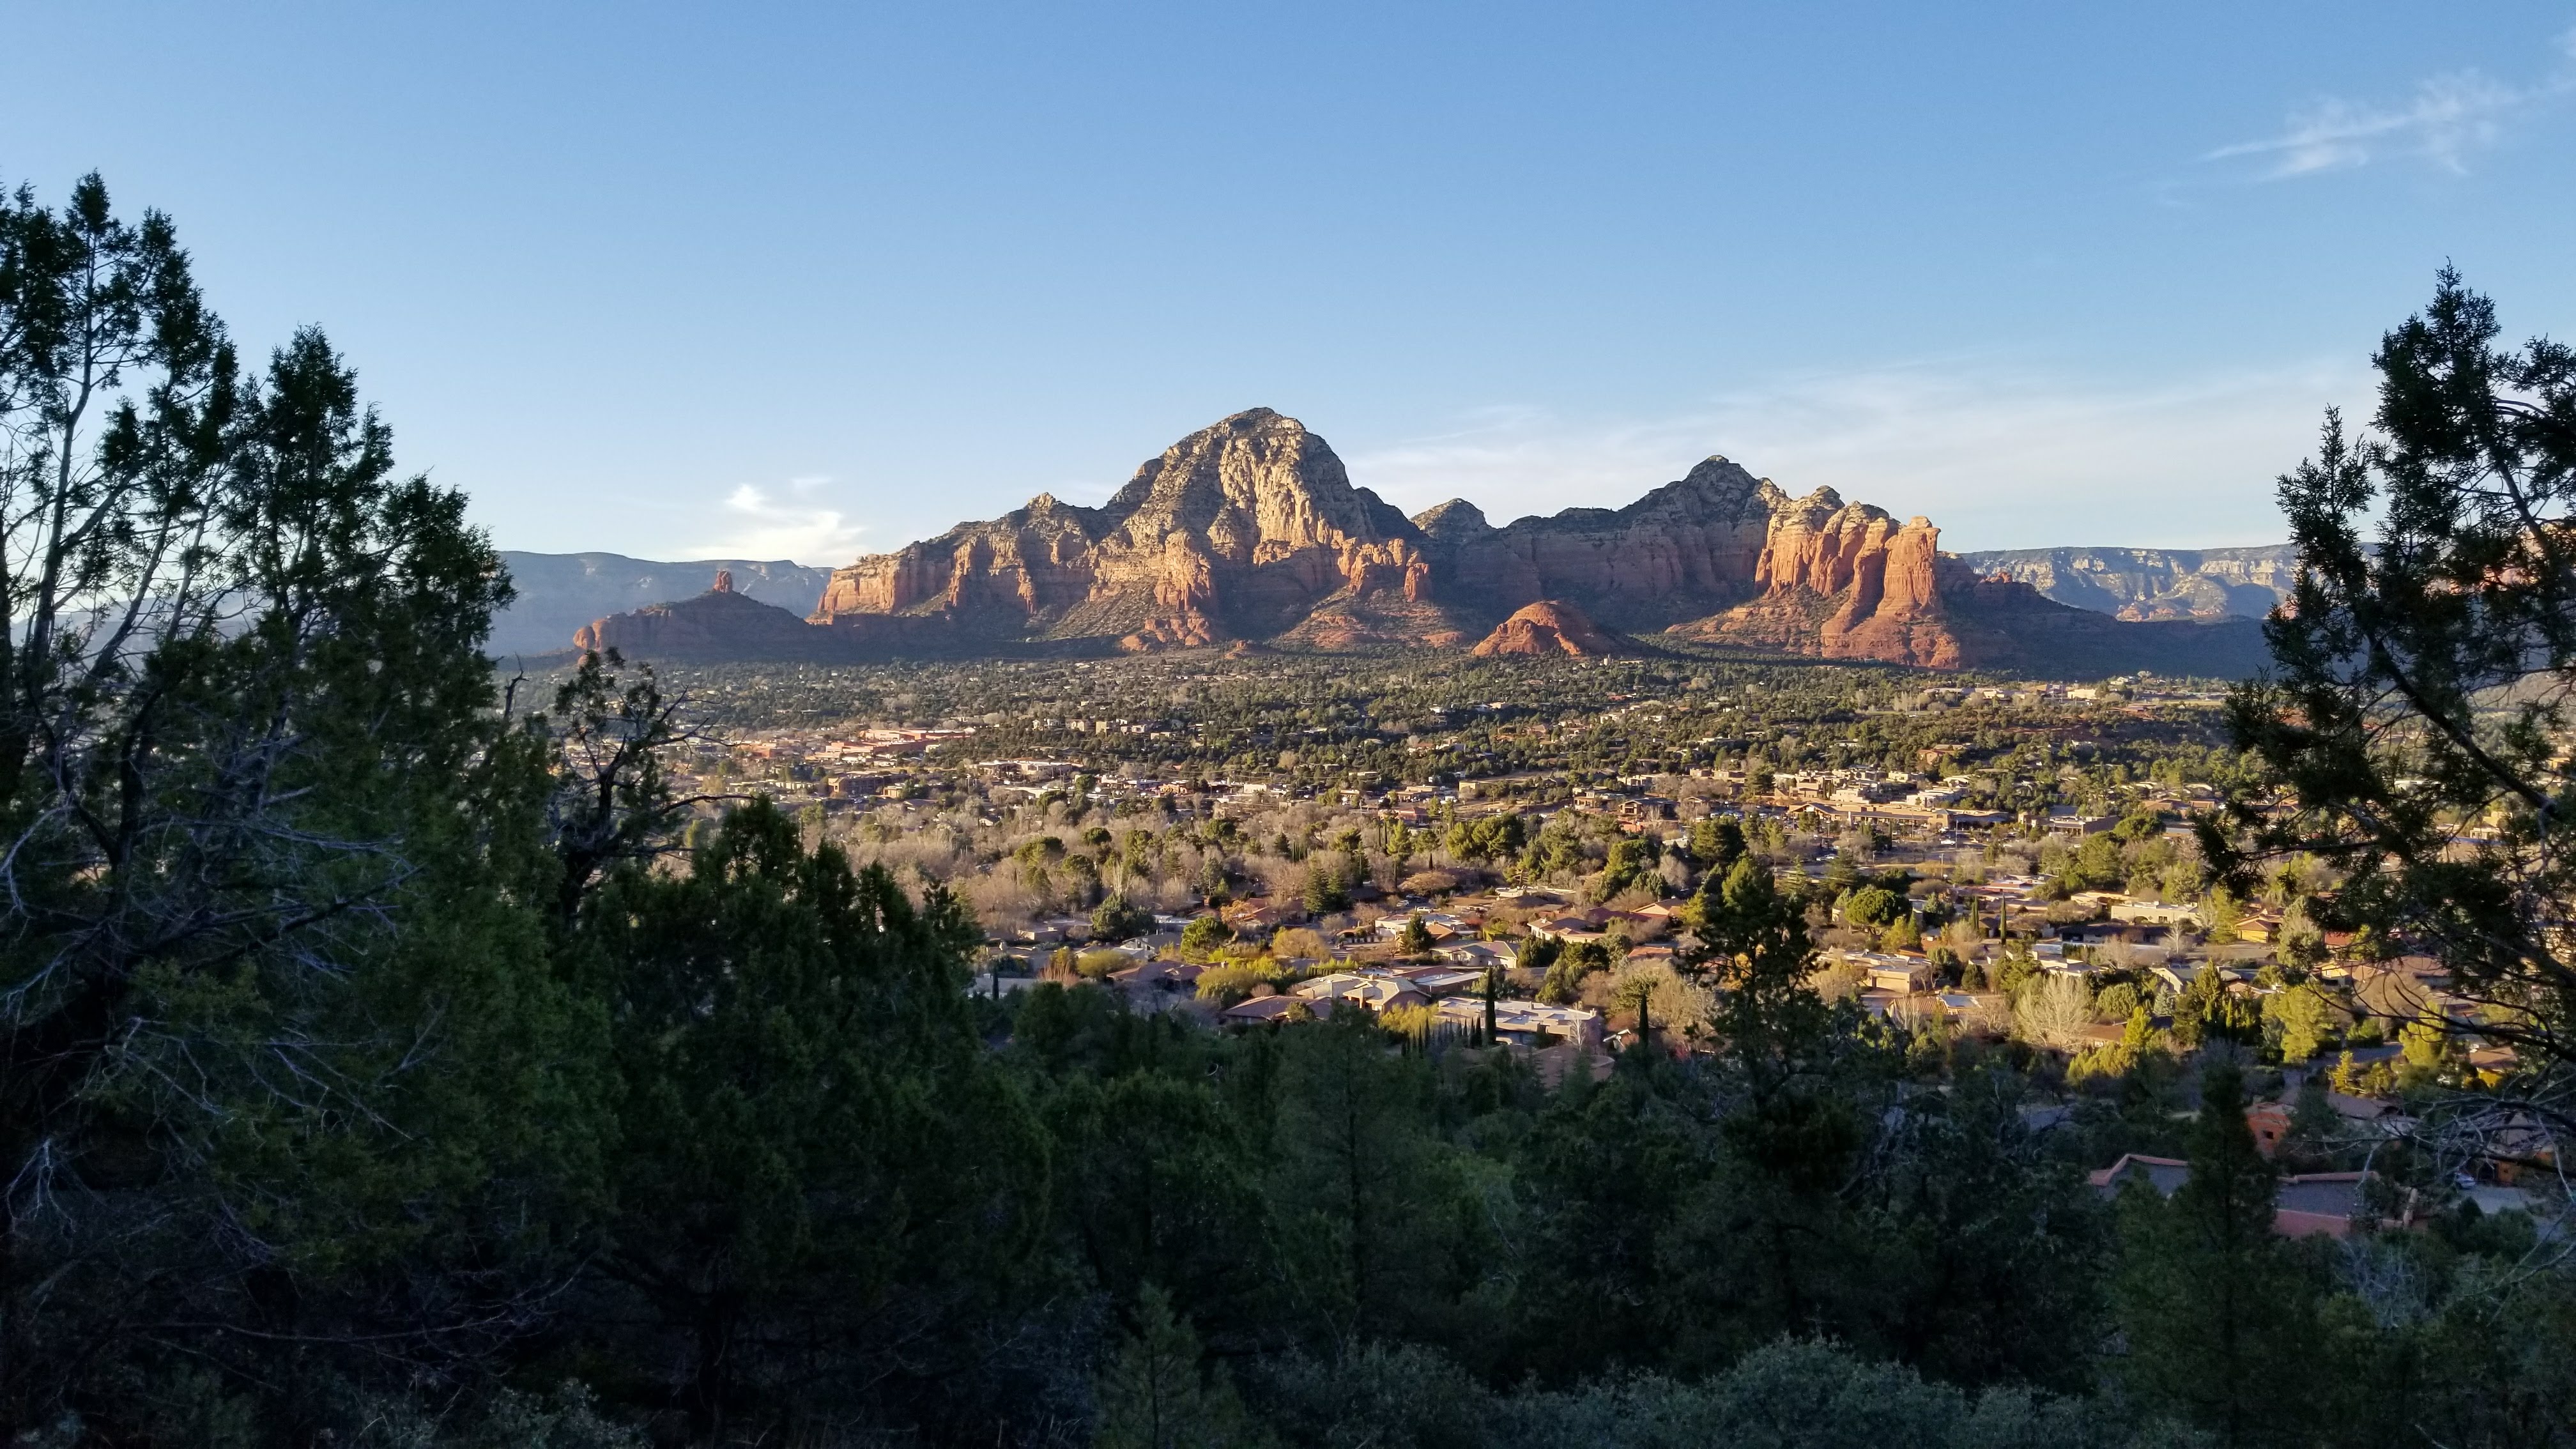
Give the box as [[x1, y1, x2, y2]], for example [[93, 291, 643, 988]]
[[579, 408, 2262, 673]]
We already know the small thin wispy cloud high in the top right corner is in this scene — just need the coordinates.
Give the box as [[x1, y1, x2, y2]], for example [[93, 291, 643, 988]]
[[2200, 28, 2576, 180]]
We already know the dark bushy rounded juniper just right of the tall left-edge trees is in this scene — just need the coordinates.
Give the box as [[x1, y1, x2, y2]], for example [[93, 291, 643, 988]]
[[569, 799, 1043, 1436]]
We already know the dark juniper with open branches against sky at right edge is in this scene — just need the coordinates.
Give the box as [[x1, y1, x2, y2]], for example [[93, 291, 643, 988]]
[[2202, 268, 2576, 1132]]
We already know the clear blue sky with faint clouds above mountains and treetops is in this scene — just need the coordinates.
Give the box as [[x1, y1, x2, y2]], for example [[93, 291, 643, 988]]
[[0, 0, 2576, 562]]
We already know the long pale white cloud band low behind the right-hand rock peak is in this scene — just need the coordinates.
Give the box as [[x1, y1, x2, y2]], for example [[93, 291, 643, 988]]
[[1350, 361, 2370, 549]]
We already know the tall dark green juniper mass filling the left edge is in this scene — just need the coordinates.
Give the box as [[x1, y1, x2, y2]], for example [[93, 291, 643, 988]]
[[0, 175, 585, 1439]]
